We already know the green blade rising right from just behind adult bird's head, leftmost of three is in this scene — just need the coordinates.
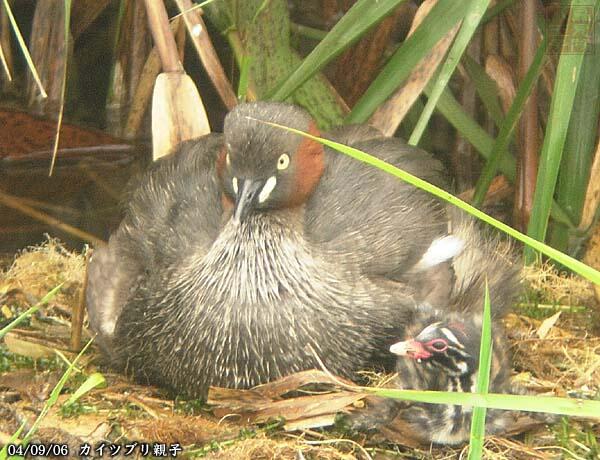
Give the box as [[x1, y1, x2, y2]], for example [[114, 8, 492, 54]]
[[266, 0, 404, 101]]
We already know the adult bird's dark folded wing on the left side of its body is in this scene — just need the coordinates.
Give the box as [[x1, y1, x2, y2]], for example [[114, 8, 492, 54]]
[[86, 134, 222, 349]]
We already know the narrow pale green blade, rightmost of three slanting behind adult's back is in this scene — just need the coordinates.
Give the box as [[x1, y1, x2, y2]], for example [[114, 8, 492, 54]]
[[408, 0, 490, 145]]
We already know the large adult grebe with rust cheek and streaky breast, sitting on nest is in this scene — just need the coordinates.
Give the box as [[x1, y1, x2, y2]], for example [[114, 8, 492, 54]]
[[88, 103, 446, 396]]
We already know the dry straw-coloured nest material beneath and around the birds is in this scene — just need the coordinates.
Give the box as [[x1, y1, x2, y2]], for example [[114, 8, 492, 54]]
[[0, 240, 600, 460]]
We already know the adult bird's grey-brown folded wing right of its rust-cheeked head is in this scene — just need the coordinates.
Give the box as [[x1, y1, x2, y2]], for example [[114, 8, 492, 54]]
[[305, 128, 447, 279]]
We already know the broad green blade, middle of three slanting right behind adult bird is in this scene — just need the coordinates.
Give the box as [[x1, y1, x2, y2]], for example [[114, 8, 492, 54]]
[[346, 0, 468, 123]]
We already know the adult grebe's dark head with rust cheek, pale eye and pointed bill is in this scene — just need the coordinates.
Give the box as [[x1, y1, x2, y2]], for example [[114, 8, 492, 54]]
[[217, 102, 324, 222]]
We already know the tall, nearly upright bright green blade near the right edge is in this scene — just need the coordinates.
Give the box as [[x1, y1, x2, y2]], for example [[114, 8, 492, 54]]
[[526, 0, 600, 261]]
